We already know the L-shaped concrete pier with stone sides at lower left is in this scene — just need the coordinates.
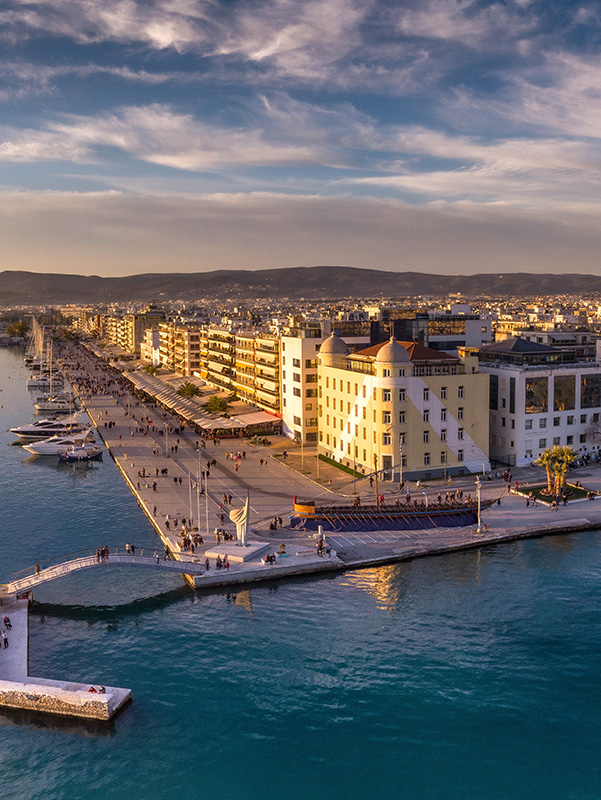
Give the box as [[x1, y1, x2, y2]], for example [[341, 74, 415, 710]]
[[0, 597, 131, 720]]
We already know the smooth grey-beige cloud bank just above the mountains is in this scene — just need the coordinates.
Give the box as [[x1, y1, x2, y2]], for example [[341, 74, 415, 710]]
[[0, 192, 601, 276]]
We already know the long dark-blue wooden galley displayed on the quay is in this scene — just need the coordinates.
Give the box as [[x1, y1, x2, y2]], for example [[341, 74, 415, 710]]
[[290, 497, 495, 531]]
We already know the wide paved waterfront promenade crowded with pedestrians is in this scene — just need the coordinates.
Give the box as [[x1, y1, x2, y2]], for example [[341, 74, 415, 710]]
[[47, 340, 601, 586]]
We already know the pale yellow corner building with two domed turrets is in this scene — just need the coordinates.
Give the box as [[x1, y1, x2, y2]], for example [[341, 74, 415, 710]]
[[318, 335, 490, 480]]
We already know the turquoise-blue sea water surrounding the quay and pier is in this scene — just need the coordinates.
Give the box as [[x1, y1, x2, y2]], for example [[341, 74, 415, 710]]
[[0, 351, 601, 800]]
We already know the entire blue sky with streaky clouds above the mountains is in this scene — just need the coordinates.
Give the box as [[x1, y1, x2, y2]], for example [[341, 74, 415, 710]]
[[0, 0, 601, 276]]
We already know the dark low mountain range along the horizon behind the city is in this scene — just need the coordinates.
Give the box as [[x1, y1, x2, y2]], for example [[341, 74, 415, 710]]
[[0, 266, 601, 306]]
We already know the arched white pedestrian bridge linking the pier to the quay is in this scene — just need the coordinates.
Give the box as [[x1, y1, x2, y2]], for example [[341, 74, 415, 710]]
[[0, 545, 211, 596]]
